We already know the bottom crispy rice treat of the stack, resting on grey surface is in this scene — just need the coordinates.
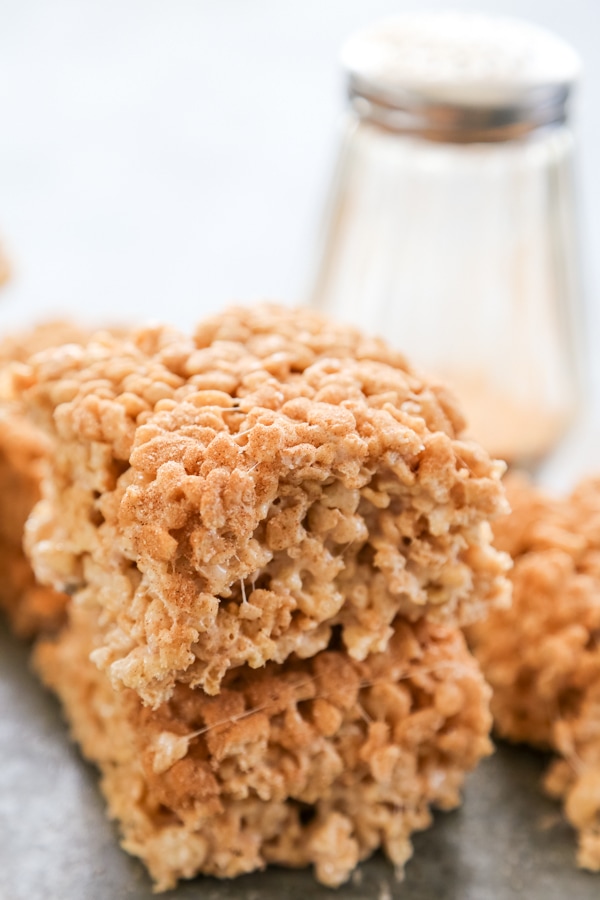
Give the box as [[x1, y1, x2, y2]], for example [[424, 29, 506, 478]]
[[36, 607, 491, 890]]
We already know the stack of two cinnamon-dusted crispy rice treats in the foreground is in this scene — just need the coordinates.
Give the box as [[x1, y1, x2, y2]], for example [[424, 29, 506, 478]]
[[4, 306, 508, 888]]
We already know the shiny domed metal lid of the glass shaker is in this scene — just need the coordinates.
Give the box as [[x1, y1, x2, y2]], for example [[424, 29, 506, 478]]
[[342, 12, 581, 142]]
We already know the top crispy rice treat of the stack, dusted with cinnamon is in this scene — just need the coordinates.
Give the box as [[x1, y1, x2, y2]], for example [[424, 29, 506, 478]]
[[15, 306, 508, 706]]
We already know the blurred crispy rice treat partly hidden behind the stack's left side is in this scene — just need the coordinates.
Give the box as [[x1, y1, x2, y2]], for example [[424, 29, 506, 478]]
[[0, 322, 89, 637]]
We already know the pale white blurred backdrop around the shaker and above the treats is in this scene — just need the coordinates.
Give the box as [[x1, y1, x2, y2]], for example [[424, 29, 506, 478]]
[[0, 0, 600, 486]]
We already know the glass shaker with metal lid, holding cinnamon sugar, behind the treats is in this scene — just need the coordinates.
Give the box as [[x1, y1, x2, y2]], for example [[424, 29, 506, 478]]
[[311, 13, 581, 466]]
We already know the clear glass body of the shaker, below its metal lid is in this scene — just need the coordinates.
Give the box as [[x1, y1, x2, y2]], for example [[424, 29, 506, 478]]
[[312, 114, 580, 464]]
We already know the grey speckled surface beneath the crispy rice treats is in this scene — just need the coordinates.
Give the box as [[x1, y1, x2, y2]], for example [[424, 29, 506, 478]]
[[0, 627, 600, 900]]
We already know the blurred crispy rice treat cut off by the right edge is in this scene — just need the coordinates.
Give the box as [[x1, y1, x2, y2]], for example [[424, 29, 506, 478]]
[[469, 479, 600, 871]]
